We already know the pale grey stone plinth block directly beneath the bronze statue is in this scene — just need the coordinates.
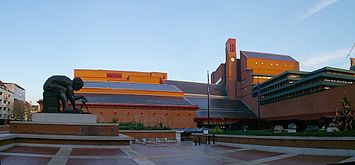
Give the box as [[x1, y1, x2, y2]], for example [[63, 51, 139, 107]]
[[32, 113, 97, 124]]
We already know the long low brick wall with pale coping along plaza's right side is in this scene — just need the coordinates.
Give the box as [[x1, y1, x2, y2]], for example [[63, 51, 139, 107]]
[[192, 134, 355, 150]]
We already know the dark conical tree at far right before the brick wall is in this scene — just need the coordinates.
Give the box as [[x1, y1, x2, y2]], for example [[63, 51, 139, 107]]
[[335, 96, 354, 131]]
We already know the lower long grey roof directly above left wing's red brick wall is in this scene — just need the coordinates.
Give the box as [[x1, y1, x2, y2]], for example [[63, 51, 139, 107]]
[[83, 94, 193, 106]]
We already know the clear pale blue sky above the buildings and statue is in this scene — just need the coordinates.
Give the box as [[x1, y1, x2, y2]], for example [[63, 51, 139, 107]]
[[0, 0, 355, 103]]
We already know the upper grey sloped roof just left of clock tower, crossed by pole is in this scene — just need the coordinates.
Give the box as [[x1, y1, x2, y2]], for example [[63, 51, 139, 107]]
[[165, 80, 227, 96]]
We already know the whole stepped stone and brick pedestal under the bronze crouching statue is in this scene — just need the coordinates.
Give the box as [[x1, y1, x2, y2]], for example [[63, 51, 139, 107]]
[[10, 113, 132, 145]]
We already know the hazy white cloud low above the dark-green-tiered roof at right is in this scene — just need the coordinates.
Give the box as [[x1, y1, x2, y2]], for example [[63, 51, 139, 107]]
[[301, 48, 350, 71]]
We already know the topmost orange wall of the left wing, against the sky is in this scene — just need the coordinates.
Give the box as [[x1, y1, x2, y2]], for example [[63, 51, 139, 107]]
[[74, 69, 167, 84]]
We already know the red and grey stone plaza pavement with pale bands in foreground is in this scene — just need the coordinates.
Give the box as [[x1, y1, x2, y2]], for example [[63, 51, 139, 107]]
[[0, 142, 354, 165]]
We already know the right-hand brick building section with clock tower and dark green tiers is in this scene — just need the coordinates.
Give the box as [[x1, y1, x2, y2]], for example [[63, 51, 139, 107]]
[[211, 39, 355, 130]]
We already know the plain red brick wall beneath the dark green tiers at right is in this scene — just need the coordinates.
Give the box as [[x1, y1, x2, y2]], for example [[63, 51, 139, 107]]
[[261, 84, 355, 120]]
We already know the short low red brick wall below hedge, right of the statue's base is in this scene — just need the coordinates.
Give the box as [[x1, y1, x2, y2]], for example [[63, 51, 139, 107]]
[[120, 130, 176, 139]]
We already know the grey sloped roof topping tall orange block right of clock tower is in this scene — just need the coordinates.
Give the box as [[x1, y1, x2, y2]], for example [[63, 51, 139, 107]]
[[240, 51, 297, 62]]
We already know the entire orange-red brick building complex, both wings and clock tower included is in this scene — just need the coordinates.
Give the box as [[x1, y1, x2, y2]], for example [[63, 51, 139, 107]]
[[38, 39, 355, 129]]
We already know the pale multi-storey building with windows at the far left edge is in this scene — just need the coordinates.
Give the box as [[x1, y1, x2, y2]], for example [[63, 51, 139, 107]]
[[0, 81, 14, 124]]
